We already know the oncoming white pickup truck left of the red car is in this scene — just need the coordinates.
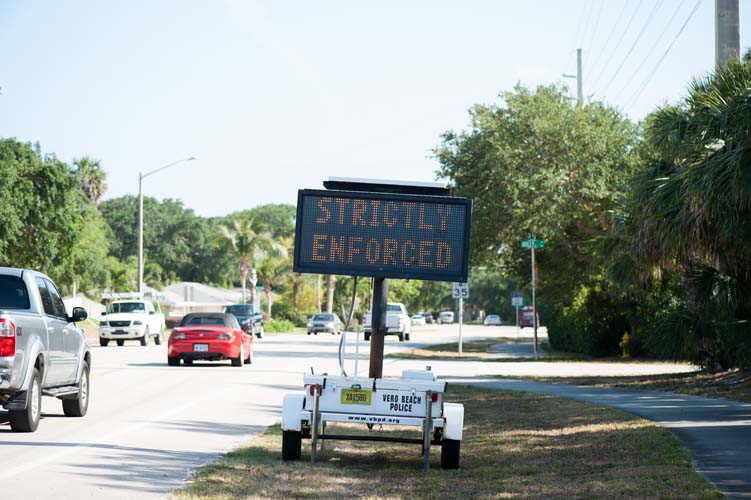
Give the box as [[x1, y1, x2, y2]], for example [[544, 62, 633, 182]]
[[99, 300, 164, 347]]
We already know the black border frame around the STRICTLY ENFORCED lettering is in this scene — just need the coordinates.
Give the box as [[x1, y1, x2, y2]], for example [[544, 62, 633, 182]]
[[292, 189, 472, 282]]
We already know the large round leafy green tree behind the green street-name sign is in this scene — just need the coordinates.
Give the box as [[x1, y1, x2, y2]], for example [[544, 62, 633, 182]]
[[435, 86, 639, 352]]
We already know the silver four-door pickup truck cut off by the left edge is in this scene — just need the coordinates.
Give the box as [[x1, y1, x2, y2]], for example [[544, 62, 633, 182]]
[[0, 267, 91, 432]]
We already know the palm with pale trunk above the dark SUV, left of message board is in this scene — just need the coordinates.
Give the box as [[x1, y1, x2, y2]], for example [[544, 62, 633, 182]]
[[216, 218, 282, 305]]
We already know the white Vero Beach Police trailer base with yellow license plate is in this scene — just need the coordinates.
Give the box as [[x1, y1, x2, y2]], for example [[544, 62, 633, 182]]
[[282, 369, 464, 471]]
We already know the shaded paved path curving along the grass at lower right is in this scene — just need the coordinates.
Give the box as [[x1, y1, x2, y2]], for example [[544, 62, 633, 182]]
[[445, 377, 751, 500]]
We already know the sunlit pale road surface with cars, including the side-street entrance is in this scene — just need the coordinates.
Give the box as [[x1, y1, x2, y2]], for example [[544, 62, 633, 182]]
[[0, 326, 700, 500]]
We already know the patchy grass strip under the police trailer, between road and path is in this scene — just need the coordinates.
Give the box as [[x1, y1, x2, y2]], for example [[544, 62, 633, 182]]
[[173, 386, 723, 500]]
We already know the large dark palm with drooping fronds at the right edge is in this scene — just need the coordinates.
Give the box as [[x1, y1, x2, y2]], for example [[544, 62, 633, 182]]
[[629, 52, 751, 367]]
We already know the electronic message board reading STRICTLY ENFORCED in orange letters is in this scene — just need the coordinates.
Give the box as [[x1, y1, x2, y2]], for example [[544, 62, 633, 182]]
[[294, 189, 472, 282]]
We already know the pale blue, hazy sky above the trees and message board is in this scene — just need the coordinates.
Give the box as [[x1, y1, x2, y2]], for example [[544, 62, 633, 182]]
[[0, 0, 751, 216]]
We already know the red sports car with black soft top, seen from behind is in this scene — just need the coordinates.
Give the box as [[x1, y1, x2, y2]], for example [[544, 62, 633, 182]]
[[167, 312, 253, 366]]
